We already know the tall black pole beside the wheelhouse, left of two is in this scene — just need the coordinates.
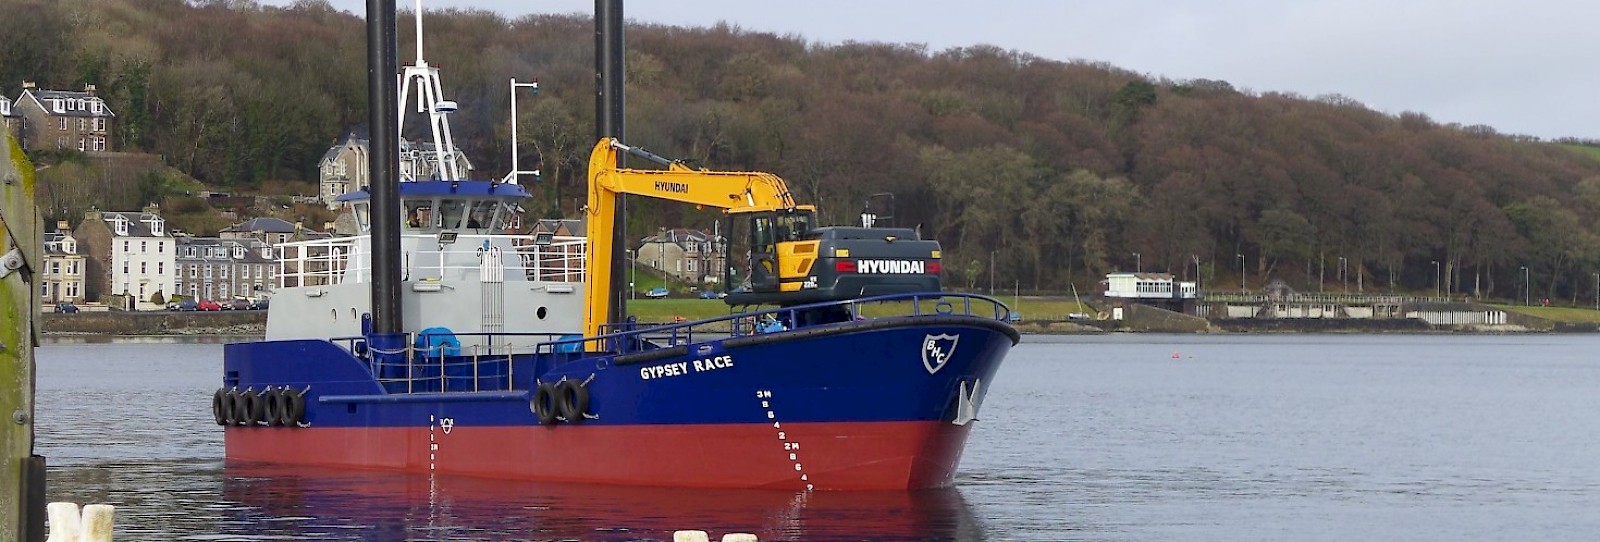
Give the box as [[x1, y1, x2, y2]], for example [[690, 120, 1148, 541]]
[[366, 0, 403, 338]]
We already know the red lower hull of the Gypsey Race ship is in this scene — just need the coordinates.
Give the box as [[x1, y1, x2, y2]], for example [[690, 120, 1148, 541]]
[[226, 420, 971, 491]]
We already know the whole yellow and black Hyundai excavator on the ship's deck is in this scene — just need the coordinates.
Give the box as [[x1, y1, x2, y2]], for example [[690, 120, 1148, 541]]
[[584, 137, 941, 337]]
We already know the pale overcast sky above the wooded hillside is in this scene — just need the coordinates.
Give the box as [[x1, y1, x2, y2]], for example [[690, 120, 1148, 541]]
[[262, 0, 1600, 139]]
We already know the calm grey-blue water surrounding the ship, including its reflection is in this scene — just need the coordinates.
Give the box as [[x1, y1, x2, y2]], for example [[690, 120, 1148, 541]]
[[37, 334, 1600, 540]]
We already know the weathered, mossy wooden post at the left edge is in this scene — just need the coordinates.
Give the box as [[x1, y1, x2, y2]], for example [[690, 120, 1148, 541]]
[[0, 120, 45, 542]]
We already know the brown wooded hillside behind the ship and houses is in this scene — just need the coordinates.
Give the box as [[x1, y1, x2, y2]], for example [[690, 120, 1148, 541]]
[[9, 0, 1600, 305]]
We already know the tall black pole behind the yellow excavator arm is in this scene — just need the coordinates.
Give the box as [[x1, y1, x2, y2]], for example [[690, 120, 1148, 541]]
[[589, 0, 627, 330]]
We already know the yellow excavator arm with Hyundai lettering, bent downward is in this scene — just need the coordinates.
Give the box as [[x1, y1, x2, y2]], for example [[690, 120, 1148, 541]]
[[584, 137, 813, 337]]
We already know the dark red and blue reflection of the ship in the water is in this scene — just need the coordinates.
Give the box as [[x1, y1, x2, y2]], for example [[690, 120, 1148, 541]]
[[222, 464, 984, 540]]
